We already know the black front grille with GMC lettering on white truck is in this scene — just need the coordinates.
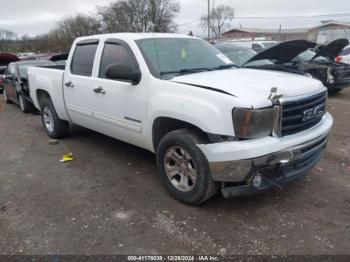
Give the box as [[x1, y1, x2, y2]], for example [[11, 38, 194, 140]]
[[281, 92, 327, 136]]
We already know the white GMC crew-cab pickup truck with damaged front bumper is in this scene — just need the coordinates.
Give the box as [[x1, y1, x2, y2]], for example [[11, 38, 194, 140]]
[[29, 33, 333, 204]]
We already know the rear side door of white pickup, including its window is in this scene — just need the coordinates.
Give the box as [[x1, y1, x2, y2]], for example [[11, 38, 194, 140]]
[[63, 39, 99, 128]]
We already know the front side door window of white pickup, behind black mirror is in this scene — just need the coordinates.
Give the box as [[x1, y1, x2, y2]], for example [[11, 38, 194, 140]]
[[99, 43, 136, 79]]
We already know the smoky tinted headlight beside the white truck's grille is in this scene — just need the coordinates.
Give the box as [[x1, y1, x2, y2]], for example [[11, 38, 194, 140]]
[[232, 108, 275, 139]]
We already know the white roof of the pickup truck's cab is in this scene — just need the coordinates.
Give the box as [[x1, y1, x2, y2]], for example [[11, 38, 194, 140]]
[[76, 33, 197, 41]]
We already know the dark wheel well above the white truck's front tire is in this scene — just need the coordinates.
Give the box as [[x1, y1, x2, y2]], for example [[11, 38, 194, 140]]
[[152, 117, 208, 151]]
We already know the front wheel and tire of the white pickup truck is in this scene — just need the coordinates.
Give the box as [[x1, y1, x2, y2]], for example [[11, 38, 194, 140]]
[[157, 129, 219, 205]]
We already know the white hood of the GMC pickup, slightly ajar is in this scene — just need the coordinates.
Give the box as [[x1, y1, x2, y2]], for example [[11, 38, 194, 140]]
[[171, 69, 324, 108]]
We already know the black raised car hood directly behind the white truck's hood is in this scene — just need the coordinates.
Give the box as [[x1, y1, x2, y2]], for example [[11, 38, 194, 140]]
[[244, 40, 316, 65]]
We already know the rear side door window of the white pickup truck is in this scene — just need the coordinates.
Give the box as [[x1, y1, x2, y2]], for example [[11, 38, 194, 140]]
[[71, 43, 98, 76]]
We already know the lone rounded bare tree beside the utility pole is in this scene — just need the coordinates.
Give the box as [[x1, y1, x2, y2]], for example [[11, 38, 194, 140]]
[[201, 5, 235, 38]]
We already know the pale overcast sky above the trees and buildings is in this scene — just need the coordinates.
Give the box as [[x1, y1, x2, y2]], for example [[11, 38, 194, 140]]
[[0, 0, 350, 36]]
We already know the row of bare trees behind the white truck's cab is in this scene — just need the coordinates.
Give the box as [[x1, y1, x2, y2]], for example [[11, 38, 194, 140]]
[[0, 0, 180, 53]]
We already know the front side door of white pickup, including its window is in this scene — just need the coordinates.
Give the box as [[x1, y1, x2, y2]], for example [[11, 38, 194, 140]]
[[93, 39, 147, 145]]
